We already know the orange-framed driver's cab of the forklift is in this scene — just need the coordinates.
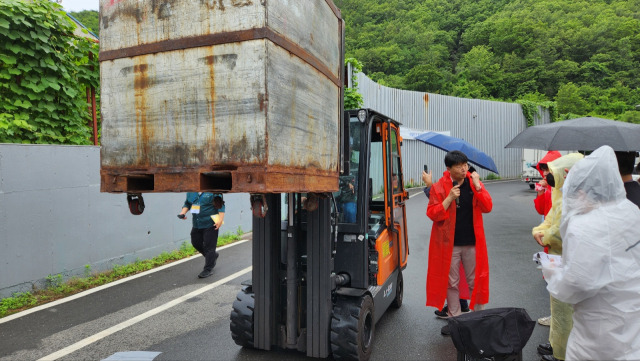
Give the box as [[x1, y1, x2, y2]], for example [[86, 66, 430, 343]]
[[334, 109, 409, 289]]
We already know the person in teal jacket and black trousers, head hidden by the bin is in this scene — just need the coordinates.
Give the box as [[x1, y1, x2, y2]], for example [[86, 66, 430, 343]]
[[178, 192, 225, 278]]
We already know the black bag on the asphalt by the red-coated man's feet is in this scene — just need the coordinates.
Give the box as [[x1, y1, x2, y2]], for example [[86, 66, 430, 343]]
[[449, 307, 536, 358]]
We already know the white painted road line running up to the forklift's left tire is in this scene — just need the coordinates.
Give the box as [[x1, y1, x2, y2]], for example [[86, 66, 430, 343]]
[[38, 267, 252, 361]]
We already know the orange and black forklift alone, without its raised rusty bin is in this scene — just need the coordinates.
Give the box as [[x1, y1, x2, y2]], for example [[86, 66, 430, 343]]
[[231, 109, 409, 360]]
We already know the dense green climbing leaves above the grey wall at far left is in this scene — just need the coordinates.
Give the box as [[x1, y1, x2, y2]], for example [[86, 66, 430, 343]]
[[0, 0, 99, 144]]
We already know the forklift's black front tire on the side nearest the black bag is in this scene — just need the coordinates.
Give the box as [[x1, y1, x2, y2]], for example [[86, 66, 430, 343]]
[[331, 295, 375, 361]]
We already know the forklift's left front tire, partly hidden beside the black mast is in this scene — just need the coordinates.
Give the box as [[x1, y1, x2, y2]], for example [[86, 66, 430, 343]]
[[231, 286, 255, 348]]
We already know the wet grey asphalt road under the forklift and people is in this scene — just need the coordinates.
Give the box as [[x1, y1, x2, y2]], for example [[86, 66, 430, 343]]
[[0, 181, 549, 360]]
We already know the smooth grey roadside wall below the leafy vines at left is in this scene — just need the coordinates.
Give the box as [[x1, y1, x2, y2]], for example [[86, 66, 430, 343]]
[[0, 144, 251, 297]]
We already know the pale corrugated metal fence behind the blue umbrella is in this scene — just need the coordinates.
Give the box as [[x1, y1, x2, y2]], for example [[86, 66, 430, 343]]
[[356, 73, 550, 184]]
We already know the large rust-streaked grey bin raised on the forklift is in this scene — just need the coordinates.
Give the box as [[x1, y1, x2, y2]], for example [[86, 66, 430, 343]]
[[100, 0, 344, 193]]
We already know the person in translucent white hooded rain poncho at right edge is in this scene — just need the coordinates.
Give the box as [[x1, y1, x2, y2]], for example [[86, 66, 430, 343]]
[[543, 146, 640, 360]]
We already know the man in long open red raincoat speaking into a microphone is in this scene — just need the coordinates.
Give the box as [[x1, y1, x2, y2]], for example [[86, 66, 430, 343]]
[[427, 151, 493, 336]]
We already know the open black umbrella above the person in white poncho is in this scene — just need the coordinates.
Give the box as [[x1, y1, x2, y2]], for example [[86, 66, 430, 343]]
[[505, 117, 640, 151]]
